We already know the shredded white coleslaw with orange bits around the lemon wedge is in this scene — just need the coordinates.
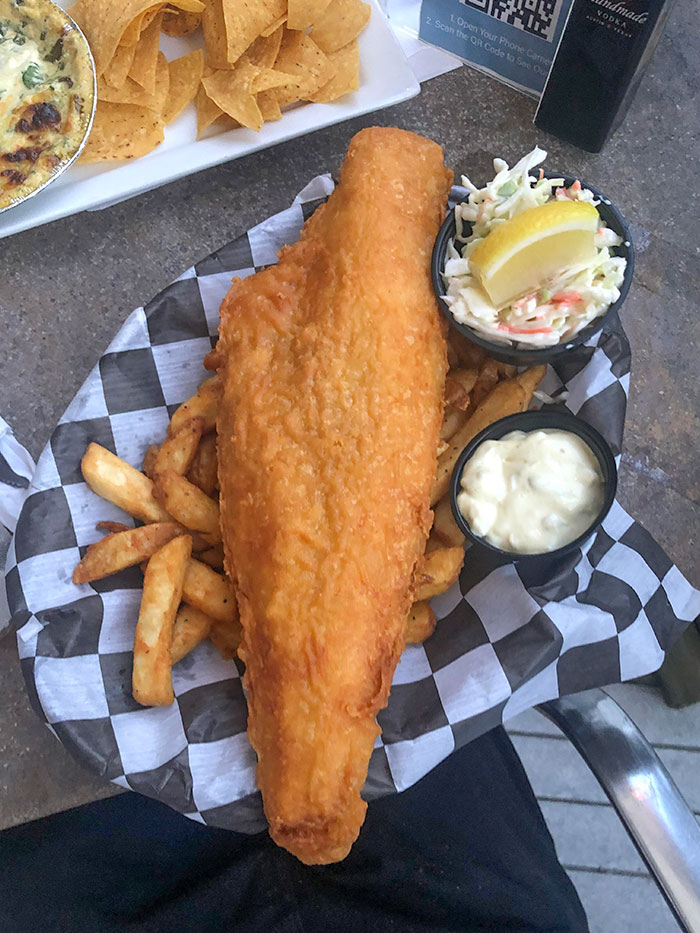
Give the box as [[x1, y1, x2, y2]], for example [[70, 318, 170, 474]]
[[442, 146, 627, 347]]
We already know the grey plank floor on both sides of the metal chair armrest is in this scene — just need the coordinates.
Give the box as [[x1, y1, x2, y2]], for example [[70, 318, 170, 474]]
[[508, 684, 700, 933]]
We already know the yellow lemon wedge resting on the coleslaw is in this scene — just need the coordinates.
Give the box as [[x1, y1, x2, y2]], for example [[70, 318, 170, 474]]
[[469, 201, 600, 308]]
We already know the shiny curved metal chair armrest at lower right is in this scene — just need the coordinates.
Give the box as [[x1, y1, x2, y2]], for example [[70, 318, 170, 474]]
[[537, 689, 700, 933]]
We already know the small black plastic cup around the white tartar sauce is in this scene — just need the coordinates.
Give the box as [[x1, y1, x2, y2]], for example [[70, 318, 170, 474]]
[[450, 411, 617, 572]]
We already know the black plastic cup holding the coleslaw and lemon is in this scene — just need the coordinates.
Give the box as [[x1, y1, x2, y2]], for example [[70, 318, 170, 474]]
[[430, 172, 634, 366]]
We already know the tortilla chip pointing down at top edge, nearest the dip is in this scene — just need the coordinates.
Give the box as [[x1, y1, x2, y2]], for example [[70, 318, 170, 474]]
[[71, 0, 204, 74]]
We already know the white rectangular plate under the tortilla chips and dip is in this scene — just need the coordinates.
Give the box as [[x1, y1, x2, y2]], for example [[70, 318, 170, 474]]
[[0, 0, 420, 238]]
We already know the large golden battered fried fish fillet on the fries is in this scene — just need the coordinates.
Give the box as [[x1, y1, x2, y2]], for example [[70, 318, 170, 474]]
[[217, 128, 452, 864]]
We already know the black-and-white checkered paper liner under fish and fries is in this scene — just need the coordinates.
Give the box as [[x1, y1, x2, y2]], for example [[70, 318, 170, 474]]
[[6, 176, 700, 832]]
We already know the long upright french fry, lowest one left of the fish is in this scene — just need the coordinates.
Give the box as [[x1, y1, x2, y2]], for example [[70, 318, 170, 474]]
[[131, 535, 192, 706]]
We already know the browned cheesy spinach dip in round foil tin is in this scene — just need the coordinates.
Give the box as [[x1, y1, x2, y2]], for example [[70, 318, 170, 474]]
[[0, 0, 94, 211]]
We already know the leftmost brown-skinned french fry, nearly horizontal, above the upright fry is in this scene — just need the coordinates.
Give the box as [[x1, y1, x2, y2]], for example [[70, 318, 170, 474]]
[[73, 522, 184, 584]]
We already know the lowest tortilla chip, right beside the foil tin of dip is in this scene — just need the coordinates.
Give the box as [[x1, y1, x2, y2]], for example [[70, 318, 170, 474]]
[[80, 101, 163, 162]]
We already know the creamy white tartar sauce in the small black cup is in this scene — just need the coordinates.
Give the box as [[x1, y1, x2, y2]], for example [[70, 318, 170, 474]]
[[457, 429, 603, 554]]
